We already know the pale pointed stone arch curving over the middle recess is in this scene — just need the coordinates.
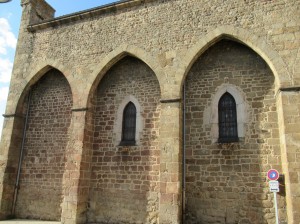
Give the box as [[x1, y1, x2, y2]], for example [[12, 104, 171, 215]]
[[87, 44, 163, 105]]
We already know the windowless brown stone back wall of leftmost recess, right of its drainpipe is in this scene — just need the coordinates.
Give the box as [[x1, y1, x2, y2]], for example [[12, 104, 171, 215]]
[[16, 70, 72, 220]]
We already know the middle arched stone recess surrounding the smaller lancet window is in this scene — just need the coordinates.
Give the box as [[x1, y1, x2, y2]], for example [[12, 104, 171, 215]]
[[86, 54, 161, 223]]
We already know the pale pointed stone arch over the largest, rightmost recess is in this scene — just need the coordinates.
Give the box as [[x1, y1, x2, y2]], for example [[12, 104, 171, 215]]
[[182, 26, 292, 90]]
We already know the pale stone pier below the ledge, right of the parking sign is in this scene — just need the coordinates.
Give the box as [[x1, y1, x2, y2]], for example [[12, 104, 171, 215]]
[[277, 88, 300, 223]]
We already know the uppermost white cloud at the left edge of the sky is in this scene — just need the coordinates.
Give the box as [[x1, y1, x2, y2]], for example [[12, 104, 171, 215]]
[[0, 18, 17, 55]]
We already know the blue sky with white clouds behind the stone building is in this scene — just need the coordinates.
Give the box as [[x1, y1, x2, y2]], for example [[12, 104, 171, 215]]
[[0, 0, 117, 139]]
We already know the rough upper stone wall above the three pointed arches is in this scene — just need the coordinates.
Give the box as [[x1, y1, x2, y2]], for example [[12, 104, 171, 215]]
[[11, 0, 300, 103]]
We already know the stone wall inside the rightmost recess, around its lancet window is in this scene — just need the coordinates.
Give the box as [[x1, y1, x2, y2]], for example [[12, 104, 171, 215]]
[[186, 40, 286, 224]]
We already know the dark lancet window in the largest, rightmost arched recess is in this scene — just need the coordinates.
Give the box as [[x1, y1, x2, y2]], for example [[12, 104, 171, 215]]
[[218, 92, 238, 143]]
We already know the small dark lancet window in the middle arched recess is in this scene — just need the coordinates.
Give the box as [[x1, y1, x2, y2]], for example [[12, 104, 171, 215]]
[[120, 102, 136, 145]]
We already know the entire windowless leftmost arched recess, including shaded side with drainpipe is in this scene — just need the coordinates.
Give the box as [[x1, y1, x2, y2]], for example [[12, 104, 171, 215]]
[[4, 66, 73, 221]]
